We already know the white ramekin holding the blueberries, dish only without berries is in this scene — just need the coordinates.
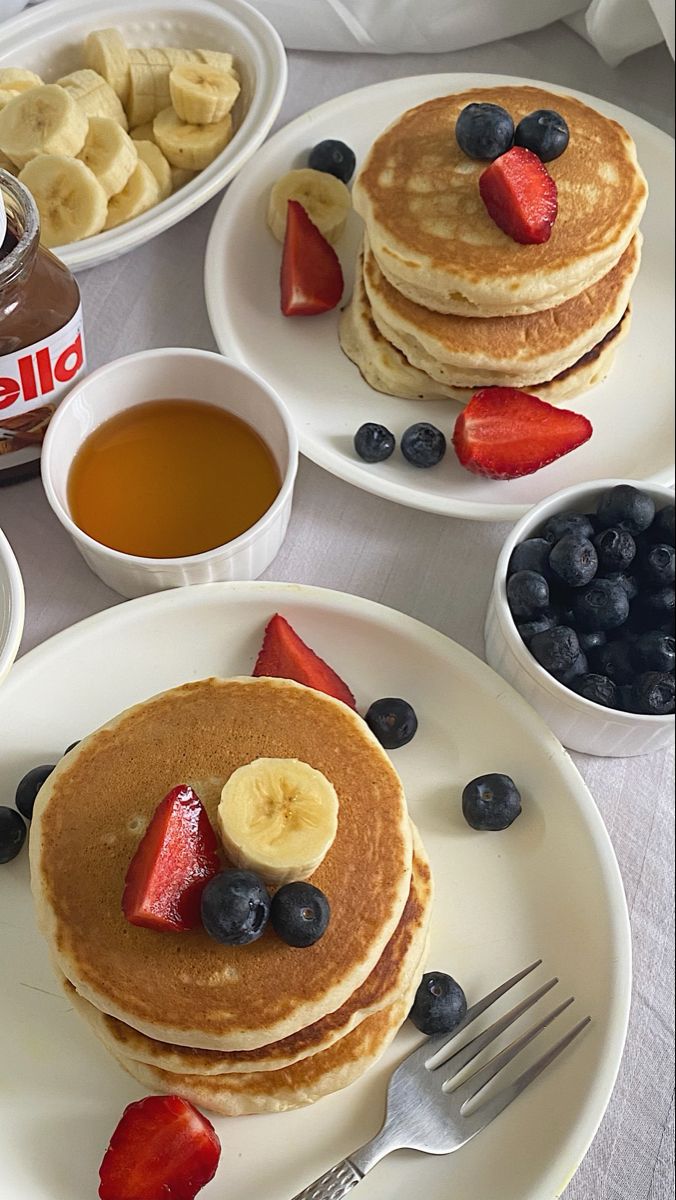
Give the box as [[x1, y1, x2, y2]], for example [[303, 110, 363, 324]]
[[485, 479, 674, 757]]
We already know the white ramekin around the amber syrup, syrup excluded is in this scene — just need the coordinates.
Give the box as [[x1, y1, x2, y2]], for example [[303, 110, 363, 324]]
[[42, 348, 298, 598]]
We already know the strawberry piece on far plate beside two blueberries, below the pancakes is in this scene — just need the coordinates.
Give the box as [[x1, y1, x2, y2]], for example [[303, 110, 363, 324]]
[[453, 388, 593, 479]]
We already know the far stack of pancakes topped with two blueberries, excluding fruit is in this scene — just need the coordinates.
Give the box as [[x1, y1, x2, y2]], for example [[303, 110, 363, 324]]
[[340, 86, 647, 402]]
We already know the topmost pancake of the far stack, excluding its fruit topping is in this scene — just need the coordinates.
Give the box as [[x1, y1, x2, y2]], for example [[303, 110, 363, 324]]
[[353, 86, 647, 317]]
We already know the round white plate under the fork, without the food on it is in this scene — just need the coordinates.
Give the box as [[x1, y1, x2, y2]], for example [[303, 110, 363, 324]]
[[0, 583, 630, 1200]]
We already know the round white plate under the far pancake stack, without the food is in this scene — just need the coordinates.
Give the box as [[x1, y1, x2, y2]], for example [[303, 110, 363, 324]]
[[205, 74, 674, 521]]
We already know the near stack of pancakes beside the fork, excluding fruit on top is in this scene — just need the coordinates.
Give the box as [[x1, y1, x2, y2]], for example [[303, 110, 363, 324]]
[[30, 678, 432, 1116]]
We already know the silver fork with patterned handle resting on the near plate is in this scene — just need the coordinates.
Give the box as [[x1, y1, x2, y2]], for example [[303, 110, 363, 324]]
[[293, 959, 591, 1200]]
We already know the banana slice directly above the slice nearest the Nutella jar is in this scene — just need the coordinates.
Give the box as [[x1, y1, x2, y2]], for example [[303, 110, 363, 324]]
[[0, 84, 89, 171]]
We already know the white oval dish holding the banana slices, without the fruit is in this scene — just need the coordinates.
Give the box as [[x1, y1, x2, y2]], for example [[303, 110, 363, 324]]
[[0, 0, 287, 271]]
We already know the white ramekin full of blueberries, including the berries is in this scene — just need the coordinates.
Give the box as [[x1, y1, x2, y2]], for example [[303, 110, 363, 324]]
[[485, 479, 676, 756]]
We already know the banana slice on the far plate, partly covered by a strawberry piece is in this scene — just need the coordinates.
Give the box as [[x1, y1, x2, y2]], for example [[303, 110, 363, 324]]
[[268, 167, 352, 242]]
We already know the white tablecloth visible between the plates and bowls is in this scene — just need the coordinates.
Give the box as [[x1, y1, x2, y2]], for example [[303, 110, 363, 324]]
[[0, 24, 674, 1200]]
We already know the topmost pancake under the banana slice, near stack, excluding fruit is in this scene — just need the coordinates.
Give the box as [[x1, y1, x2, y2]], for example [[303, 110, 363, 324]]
[[30, 678, 412, 1050]]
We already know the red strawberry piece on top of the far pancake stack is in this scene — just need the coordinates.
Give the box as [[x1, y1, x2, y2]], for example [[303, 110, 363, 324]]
[[479, 146, 558, 242]]
